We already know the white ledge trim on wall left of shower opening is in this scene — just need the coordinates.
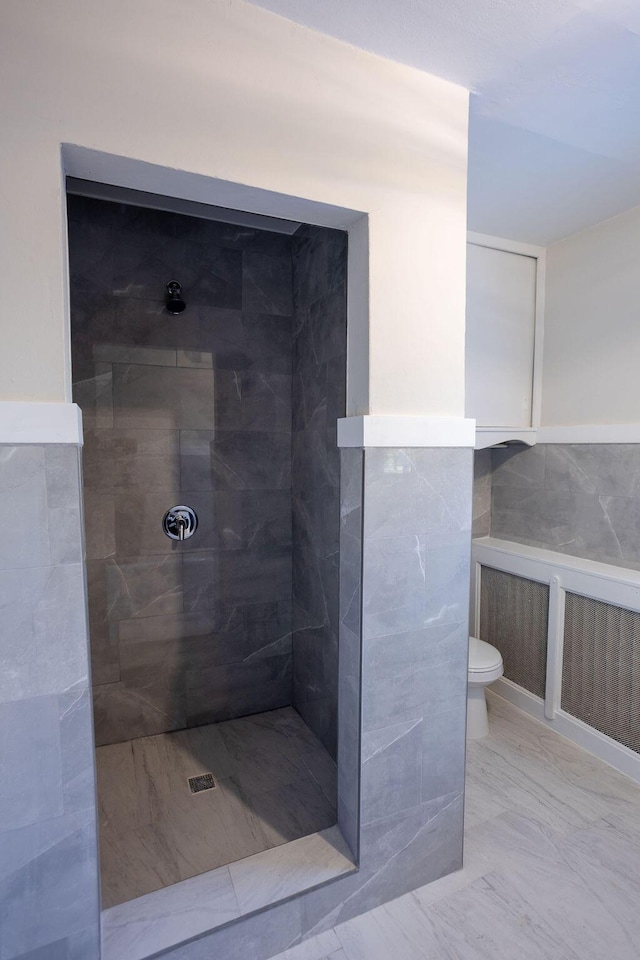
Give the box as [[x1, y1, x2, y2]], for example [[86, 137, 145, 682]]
[[0, 400, 82, 445]]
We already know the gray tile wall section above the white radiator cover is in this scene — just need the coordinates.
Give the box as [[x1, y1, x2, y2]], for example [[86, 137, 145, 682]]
[[491, 443, 640, 569]]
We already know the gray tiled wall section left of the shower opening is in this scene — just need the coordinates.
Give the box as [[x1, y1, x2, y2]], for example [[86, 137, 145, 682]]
[[0, 445, 99, 960]]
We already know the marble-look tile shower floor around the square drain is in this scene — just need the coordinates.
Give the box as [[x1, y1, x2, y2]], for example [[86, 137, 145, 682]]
[[96, 707, 336, 908]]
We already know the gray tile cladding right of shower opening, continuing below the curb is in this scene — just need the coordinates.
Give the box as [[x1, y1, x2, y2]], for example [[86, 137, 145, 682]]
[[154, 449, 472, 960]]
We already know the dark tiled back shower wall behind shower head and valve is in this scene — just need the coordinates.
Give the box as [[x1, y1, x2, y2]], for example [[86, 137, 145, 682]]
[[69, 197, 293, 744]]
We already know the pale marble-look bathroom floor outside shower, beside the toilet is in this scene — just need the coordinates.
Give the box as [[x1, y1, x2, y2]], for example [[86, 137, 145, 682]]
[[273, 694, 640, 960]]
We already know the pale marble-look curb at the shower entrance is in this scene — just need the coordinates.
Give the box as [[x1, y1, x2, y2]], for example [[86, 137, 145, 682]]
[[101, 826, 358, 960]]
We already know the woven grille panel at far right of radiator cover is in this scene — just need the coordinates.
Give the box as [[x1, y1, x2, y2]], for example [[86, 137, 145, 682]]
[[561, 593, 640, 753]]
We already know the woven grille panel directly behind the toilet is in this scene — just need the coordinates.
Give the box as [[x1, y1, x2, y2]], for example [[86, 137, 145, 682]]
[[480, 567, 549, 697]]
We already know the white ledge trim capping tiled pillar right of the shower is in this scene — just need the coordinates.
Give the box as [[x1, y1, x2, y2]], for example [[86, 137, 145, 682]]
[[338, 415, 476, 447]]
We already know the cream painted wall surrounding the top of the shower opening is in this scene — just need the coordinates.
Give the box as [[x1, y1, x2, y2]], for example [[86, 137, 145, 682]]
[[0, 0, 467, 416]]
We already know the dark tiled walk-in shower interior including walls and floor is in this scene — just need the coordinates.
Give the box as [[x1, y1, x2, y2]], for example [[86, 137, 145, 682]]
[[68, 182, 353, 908]]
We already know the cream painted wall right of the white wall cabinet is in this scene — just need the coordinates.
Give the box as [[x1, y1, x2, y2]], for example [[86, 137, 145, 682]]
[[542, 207, 640, 426]]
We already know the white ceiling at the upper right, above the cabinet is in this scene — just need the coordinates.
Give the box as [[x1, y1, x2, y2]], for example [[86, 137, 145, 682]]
[[242, 0, 640, 244]]
